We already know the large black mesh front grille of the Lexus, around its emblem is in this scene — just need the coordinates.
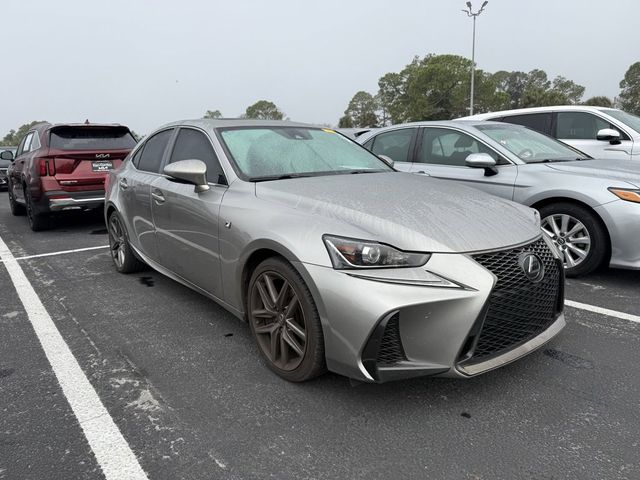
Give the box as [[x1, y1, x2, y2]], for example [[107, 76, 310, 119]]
[[469, 239, 561, 363]]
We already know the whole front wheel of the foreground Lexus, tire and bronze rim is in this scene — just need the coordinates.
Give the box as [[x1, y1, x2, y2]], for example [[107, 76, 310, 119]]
[[246, 257, 326, 382]]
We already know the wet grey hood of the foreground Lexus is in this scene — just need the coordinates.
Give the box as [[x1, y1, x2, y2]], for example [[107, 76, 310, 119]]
[[256, 172, 540, 253]]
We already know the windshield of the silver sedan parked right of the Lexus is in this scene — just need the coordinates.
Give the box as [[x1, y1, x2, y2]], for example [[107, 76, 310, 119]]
[[476, 124, 589, 163]]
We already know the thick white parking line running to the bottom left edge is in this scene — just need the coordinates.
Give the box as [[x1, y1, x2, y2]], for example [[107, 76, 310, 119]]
[[0, 234, 148, 480]]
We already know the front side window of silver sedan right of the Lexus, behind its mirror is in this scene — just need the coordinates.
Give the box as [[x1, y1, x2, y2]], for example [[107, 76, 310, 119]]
[[416, 128, 498, 167]]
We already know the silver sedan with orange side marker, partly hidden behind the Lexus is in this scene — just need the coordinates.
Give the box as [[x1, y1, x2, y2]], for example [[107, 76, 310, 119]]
[[358, 120, 640, 276]]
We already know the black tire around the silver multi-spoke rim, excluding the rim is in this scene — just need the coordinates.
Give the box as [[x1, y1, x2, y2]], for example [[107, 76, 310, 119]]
[[540, 203, 609, 277]]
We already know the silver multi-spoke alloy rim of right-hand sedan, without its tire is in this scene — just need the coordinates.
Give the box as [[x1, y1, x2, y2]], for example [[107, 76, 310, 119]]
[[542, 213, 591, 268]]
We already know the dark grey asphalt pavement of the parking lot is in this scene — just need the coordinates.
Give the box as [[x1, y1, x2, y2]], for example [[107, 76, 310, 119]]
[[0, 201, 640, 479]]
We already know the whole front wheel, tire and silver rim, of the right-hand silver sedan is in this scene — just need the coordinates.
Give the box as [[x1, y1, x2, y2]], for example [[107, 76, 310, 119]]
[[540, 203, 609, 277]]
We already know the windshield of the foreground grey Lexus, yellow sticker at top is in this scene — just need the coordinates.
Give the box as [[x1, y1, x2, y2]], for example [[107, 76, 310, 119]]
[[220, 127, 392, 181]]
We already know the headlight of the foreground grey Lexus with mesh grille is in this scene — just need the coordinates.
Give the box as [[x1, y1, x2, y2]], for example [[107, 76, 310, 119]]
[[322, 235, 431, 269]]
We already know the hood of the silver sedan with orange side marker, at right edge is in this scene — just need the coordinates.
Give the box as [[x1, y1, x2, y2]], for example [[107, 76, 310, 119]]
[[545, 159, 640, 188]]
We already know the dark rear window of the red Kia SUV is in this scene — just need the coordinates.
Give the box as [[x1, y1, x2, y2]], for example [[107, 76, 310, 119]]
[[49, 127, 136, 150]]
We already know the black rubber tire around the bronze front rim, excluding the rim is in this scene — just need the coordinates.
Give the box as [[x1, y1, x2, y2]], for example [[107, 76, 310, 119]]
[[245, 257, 326, 382]]
